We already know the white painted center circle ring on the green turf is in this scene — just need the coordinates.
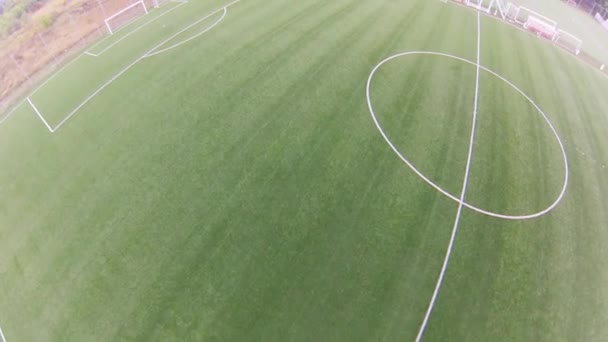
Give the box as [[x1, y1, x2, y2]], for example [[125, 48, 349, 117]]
[[366, 51, 569, 220]]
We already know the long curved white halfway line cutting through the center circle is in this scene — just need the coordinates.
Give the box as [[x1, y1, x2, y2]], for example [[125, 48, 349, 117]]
[[416, 12, 481, 342]]
